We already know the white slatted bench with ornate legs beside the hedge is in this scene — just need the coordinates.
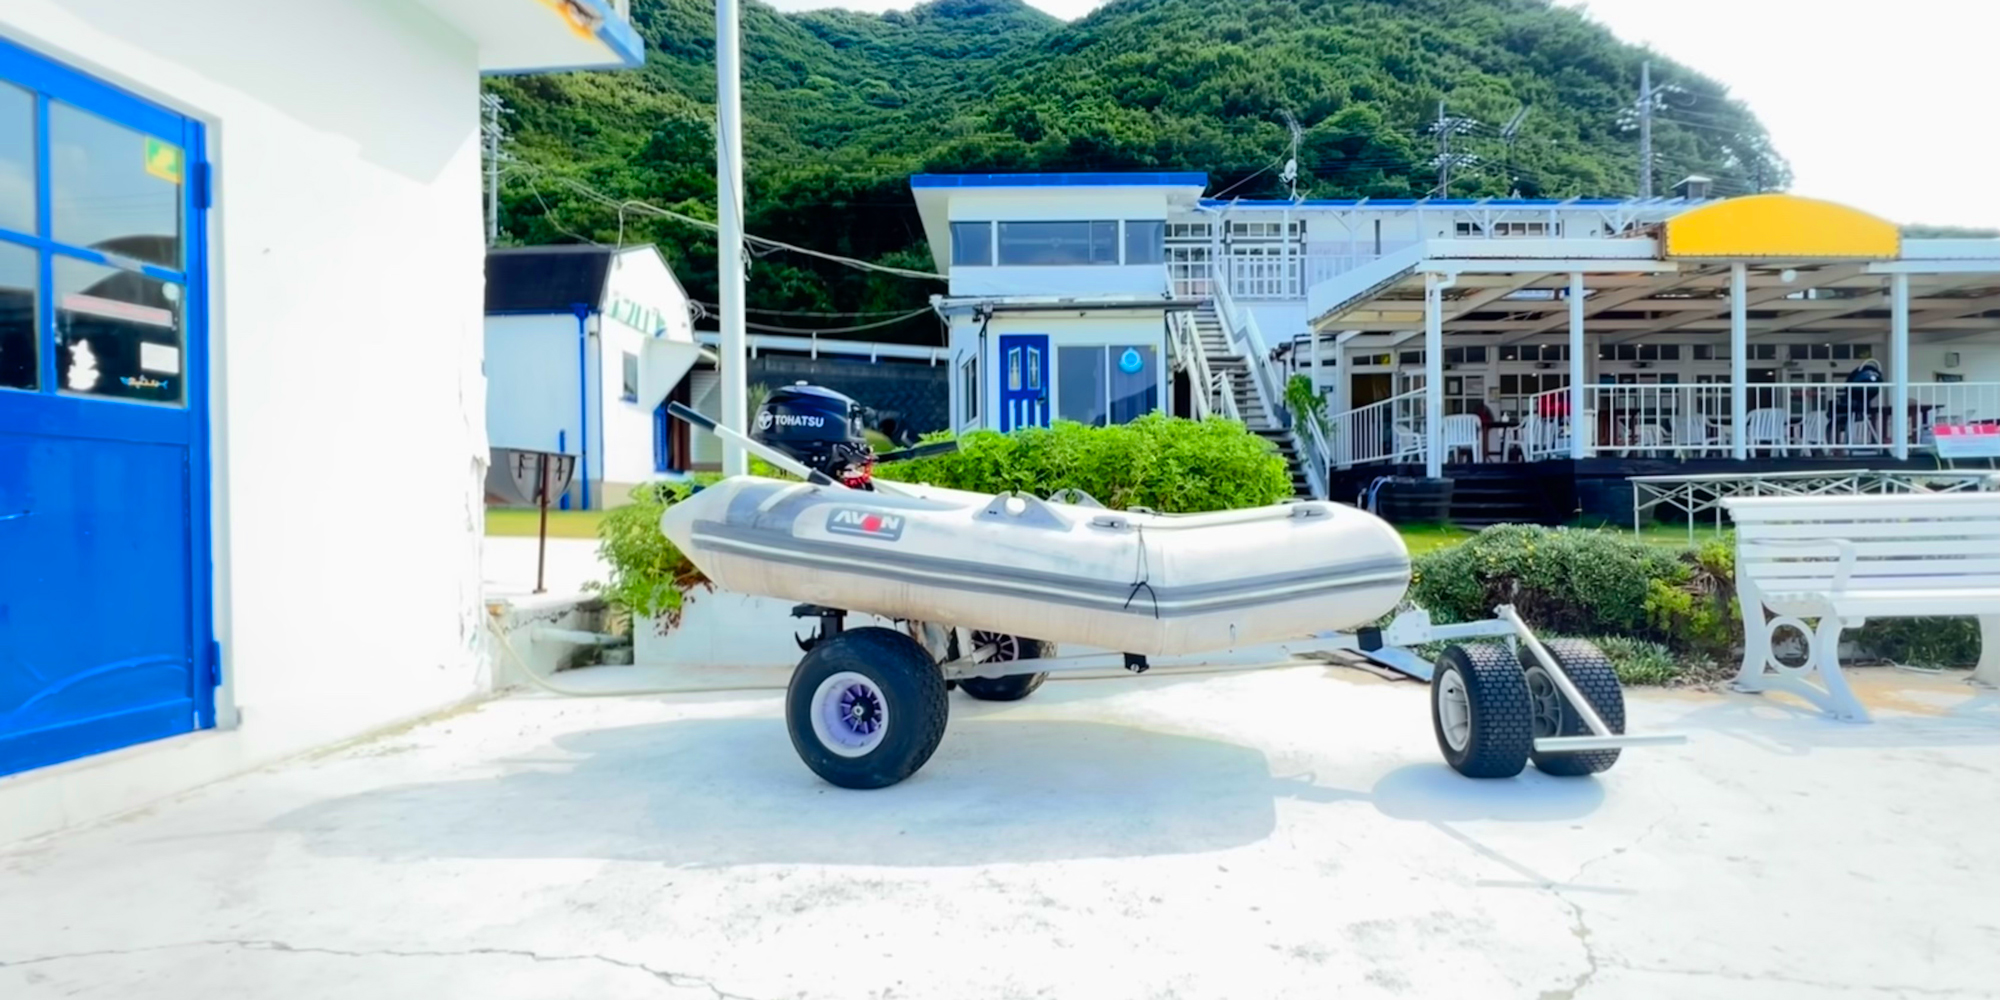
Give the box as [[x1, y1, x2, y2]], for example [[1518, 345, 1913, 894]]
[[1722, 492, 2000, 722]]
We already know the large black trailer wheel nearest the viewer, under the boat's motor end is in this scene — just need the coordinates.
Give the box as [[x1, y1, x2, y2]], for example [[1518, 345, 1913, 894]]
[[784, 628, 950, 788]]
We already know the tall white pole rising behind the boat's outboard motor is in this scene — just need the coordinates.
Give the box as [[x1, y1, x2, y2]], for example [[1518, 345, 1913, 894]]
[[716, 0, 750, 476]]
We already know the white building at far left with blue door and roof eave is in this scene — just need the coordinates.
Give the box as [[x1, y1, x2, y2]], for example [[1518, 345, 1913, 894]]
[[0, 0, 642, 840]]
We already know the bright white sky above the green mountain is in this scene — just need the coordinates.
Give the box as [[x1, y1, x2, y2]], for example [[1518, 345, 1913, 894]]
[[770, 0, 2000, 228]]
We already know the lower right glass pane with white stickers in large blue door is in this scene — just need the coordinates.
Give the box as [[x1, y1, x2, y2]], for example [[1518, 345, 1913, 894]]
[[56, 256, 184, 404]]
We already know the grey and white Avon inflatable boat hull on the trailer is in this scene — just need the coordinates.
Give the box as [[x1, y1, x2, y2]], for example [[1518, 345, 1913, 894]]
[[660, 476, 1410, 656]]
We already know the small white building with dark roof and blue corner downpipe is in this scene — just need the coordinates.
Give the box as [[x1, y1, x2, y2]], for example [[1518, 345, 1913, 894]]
[[486, 246, 700, 510]]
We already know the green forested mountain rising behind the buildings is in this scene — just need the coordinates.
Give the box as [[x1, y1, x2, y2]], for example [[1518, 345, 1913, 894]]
[[488, 0, 1788, 340]]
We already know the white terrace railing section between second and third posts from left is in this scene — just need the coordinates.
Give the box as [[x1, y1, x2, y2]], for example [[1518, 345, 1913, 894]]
[[1576, 384, 1730, 458]]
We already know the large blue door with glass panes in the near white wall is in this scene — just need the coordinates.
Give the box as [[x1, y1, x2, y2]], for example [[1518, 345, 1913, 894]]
[[0, 42, 216, 774]]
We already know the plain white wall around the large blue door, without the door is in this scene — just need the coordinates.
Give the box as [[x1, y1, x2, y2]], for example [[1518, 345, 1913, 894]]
[[0, 0, 486, 840]]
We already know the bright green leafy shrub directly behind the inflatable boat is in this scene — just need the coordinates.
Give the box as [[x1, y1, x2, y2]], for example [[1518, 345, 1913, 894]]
[[876, 414, 1292, 514]]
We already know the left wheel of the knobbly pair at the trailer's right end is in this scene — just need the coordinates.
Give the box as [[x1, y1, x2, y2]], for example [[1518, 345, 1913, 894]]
[[1430, 642, 1534, 778]]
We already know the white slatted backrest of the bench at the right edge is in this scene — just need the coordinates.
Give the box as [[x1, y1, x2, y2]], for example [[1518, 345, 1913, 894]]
[[1722, 492, 2000, 592]]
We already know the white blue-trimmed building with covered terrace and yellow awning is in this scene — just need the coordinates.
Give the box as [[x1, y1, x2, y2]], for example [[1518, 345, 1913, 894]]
[[912, 174, 2000, 510]]
